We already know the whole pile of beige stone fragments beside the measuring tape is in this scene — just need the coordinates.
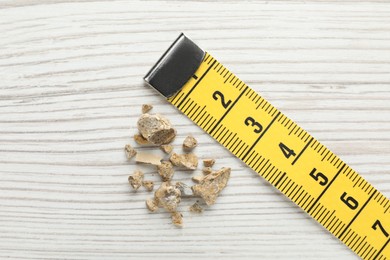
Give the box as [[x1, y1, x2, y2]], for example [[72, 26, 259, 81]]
[[125, 104, 231, 227]]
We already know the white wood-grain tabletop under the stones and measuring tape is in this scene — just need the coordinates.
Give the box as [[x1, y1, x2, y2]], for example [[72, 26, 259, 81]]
[[0, 0, 390, 259]]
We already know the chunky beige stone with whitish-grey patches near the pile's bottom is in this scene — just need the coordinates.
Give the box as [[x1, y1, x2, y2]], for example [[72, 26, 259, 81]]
[[154, 182, 181, 212]]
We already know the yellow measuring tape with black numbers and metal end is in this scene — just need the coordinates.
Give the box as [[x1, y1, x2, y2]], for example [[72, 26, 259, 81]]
[[145, 34, 390, 260]]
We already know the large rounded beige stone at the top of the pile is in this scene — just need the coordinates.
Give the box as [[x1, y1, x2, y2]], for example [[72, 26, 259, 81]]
[[137, 114, 176, 145]]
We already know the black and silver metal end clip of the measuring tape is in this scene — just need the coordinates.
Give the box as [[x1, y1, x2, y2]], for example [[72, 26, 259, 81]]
[[144, 33, 205, 98]]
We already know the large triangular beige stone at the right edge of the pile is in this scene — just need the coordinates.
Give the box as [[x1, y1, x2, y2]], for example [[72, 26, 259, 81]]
[[192, 168, 231, 206]]
